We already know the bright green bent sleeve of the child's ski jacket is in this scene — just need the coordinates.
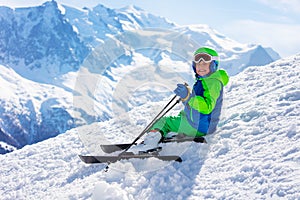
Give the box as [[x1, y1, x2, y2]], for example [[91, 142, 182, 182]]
[[188, 79, 222, 114]]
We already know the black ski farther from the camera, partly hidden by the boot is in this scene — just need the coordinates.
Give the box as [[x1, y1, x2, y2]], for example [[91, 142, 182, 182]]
[[100, 135, 207, 153]]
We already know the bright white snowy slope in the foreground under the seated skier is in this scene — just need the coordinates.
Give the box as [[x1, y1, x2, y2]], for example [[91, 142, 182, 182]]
[[0, 55, 300, 199]]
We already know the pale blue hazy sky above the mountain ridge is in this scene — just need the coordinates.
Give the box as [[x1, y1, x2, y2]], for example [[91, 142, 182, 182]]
[[0, 0, 300, 57]]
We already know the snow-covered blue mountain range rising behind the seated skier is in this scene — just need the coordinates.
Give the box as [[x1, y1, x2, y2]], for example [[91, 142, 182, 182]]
[[0, 1, 279, 153]]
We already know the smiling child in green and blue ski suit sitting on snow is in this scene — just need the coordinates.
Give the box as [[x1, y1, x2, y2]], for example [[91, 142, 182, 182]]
[[130, 47, 229, 150]]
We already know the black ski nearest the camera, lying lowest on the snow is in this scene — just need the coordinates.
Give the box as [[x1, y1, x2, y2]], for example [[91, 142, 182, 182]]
[[79, 154, 182, 164]]
